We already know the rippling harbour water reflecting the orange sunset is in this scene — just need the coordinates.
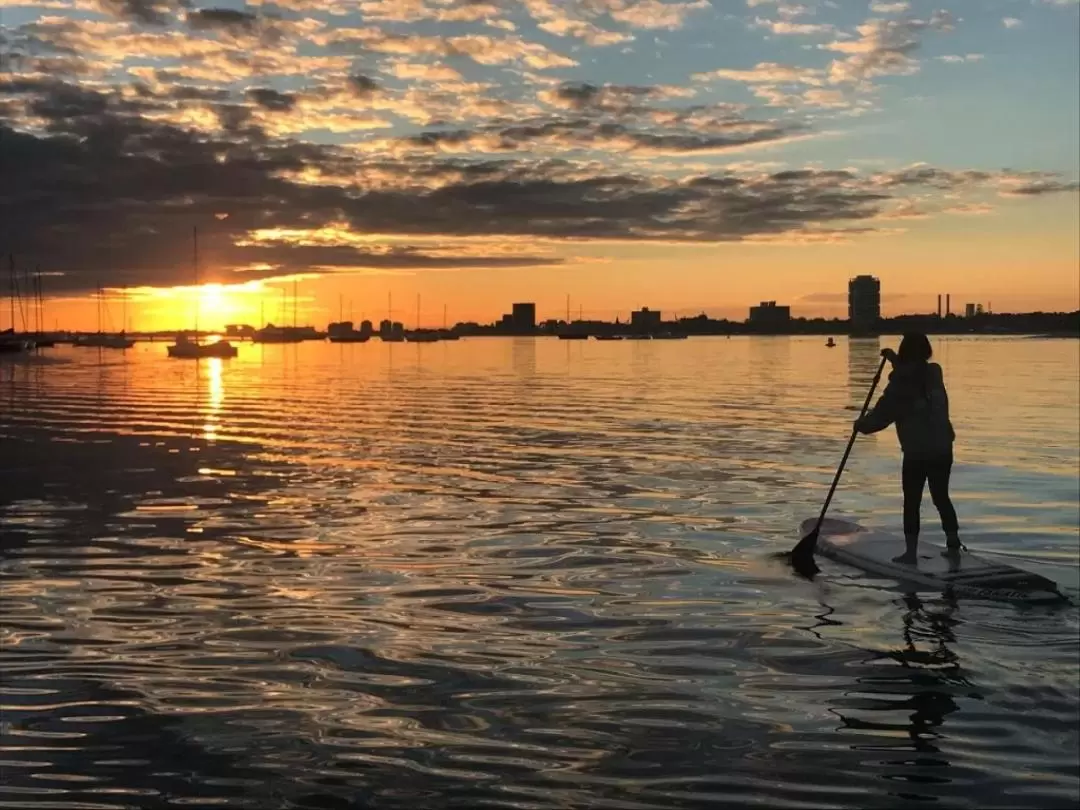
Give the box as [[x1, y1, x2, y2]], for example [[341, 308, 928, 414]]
[[0, 338, 1080, 810]]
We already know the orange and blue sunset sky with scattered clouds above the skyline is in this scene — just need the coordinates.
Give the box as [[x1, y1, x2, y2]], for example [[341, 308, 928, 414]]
[[0, 0, 1080, 329]]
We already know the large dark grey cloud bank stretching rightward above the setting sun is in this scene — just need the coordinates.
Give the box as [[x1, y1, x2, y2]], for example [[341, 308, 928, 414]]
[[0, 82, 1075, 289]]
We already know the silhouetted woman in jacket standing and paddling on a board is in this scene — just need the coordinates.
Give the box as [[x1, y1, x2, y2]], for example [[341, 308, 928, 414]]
[[855, 333, 963, 565]]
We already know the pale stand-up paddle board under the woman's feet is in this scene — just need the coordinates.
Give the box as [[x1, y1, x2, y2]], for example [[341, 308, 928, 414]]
[[799, 517, 1065, 602]]
